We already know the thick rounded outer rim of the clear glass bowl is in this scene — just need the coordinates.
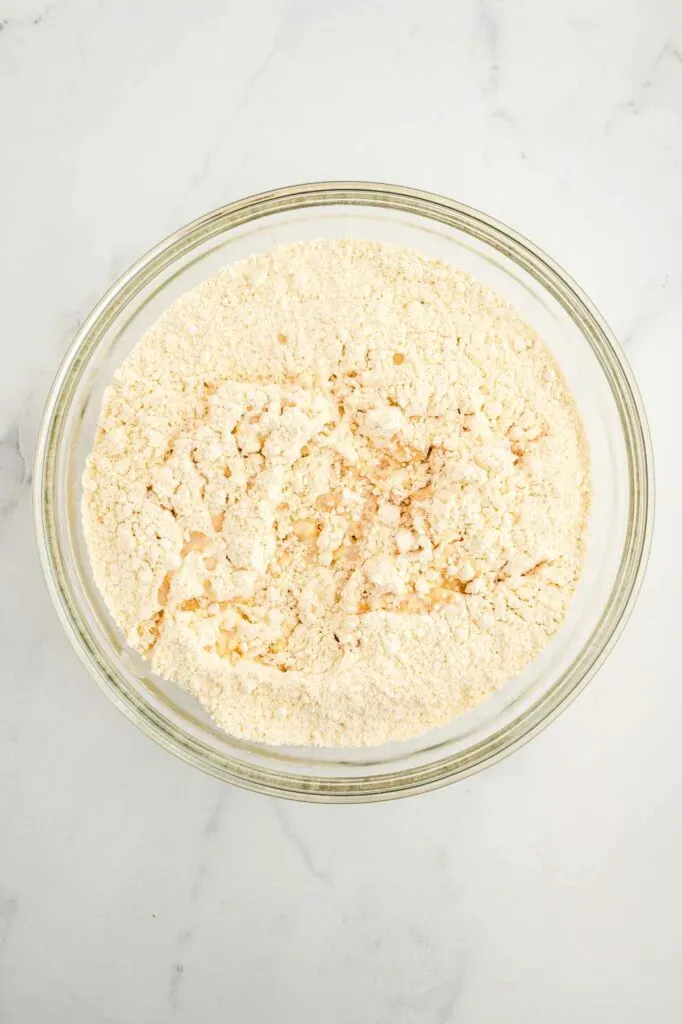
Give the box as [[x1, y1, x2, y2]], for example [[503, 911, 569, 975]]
[[33, 186, 654, 803]]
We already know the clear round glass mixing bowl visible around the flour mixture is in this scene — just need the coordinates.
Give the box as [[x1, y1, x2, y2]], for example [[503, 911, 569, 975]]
[[34, 182, 653, 802]]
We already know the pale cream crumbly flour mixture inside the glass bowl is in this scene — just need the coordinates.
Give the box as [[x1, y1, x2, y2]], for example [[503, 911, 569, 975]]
[[83, 240, 590, 746]]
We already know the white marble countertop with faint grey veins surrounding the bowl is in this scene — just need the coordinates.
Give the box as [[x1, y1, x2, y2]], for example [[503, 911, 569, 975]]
[[0, 0, 682, 1024]]
